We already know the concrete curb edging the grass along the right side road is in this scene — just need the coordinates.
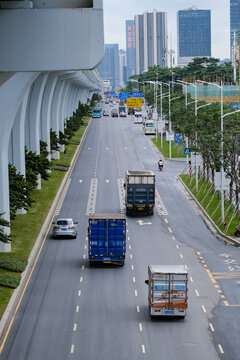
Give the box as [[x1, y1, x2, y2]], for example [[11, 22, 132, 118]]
[[177, 175, 240, 247]]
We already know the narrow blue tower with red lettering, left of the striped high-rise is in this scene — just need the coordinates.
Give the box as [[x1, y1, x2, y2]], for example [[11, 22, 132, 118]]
[[126, 20, 136, 79]]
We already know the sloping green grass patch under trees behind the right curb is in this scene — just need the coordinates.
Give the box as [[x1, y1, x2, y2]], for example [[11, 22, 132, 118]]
[[180, 174, 239, 236]]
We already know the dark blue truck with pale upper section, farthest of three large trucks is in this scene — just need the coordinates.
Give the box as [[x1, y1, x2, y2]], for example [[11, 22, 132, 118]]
[[124, 170, 155, 215]]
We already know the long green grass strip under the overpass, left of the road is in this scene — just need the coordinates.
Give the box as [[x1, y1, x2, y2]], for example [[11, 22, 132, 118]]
[[0, 117, 90, 318]]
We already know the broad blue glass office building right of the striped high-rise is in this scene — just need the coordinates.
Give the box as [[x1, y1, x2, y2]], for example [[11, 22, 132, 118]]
[[177, 6, 211, 66]]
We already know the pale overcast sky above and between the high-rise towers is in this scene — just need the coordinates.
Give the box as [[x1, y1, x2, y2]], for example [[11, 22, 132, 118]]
[[103, 0, 230, 59]]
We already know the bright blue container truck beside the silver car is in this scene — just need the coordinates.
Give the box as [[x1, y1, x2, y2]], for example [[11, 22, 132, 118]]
[[88, 214, 126, 265]]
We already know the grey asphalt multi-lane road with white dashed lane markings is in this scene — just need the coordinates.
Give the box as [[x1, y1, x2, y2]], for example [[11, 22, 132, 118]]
[[1, 105, 240, 360]]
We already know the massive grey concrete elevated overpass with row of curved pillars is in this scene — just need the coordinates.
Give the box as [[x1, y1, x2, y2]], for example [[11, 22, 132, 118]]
[[0, 0, 104, 251]]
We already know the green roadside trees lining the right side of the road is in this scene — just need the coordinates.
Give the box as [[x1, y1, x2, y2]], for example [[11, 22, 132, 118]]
[[125, 58, 240, 225]]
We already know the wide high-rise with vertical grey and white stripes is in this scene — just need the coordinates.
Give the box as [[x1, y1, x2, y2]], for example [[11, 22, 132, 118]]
[[134, 10, 168, 74]]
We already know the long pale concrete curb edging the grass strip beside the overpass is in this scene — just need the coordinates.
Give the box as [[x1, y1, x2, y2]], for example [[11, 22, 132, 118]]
[[0, 118, 92, 346]]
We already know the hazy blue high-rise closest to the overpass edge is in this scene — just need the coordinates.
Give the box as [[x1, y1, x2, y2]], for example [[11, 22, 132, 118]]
[[98, 44, 120, 89]]
